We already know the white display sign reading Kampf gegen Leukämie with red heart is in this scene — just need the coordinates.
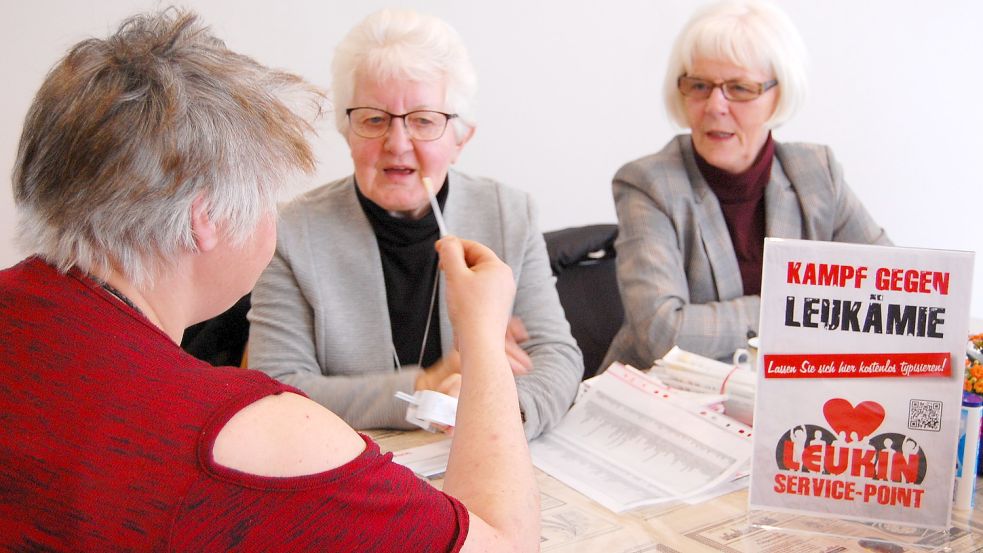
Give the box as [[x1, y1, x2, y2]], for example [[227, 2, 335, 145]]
[[750, 238, 973, 528]]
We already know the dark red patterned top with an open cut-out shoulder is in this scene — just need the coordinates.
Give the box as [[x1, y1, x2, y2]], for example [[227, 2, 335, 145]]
[[0, 258, 468, 551]]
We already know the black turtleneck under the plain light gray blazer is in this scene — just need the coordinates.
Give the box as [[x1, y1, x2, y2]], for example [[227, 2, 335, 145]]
[[355, 180, 450, 367]]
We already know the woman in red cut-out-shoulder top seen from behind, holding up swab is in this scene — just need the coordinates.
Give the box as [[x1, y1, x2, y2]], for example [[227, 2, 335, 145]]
[[0, 10, 538, 551]]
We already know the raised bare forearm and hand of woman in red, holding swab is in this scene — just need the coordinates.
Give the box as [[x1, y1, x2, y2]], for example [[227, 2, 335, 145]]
[[438, 237, 539, 551]]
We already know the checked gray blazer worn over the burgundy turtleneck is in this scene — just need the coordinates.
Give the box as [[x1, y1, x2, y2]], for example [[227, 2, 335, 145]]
[[602, 134, 891, 368]]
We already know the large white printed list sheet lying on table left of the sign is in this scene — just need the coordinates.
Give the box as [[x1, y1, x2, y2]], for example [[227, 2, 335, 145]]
[[530, 364, 751, 512]]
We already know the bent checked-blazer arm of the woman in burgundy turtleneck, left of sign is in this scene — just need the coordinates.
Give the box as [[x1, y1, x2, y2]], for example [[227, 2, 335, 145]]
[[613, 166, 760, 367]]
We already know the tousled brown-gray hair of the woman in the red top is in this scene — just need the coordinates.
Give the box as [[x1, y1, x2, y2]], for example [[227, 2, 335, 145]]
[[13, 8, 323, 285]]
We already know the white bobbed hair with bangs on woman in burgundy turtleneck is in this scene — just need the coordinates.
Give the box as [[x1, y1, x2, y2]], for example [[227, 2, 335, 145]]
[[663, 0, 807, 128]]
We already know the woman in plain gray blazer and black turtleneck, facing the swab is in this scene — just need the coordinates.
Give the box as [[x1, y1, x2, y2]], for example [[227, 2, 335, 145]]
[[249, 10, 583, 438]]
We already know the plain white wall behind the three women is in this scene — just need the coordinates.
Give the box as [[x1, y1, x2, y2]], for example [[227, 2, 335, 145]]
[[0, 0, 983, 317]]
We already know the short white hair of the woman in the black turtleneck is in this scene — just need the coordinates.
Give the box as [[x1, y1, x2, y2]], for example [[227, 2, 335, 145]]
[[331, 9, 478, 139]]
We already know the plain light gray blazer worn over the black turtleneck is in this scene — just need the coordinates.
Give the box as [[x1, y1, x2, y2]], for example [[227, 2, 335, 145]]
[[249, 171, 584, 439]]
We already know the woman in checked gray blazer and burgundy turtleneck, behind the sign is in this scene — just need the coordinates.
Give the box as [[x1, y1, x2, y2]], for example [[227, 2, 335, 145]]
[[604, 1, 890, 367]]
